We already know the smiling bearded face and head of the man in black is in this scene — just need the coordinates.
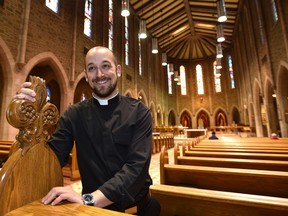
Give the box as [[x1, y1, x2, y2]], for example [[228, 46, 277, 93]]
[[85, 47, 121, 99]]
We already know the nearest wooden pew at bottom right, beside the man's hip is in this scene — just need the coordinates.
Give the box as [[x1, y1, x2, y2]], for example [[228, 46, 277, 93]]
[[150, 185, 288, 216]]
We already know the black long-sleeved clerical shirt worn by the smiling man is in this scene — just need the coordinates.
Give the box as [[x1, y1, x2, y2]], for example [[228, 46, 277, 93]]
[[49, 95, 152, 210]]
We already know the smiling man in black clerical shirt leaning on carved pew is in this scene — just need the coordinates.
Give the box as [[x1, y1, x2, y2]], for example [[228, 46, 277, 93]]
[[15, 47, 160, 216]]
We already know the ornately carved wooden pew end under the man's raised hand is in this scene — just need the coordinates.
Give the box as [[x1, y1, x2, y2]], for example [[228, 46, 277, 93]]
[[0, 77, 63, 215]]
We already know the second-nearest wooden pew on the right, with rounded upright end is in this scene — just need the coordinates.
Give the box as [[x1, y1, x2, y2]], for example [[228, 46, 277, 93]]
[[160, 147, 288, 198]]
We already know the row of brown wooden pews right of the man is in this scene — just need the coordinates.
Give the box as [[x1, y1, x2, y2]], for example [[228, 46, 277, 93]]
[[151, 135, 288, 216]]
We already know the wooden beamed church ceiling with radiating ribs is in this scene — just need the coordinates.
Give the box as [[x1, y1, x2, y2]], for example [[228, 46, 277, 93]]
[[130, 0, 241, 60]]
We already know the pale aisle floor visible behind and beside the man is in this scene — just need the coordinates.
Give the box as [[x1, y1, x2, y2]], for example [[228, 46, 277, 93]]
[[64, 148, 174, 193]]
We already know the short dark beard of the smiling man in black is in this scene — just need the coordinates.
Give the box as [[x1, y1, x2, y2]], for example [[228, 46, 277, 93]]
[[92, 78, 118, 98]]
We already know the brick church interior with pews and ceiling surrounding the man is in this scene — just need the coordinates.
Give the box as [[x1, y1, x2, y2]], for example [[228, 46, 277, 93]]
[[0, 0, 288, 216]]
